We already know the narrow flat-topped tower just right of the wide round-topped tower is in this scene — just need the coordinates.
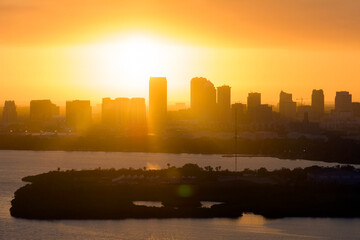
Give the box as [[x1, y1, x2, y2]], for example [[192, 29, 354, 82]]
[[217, 85, 231, 121]]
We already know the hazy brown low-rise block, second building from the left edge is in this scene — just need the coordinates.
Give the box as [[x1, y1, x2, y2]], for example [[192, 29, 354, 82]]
[[30, 99, 60, 124]]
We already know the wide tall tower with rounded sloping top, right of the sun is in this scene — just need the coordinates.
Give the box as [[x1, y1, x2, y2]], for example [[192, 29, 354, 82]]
[[190, 77, 216, 121]]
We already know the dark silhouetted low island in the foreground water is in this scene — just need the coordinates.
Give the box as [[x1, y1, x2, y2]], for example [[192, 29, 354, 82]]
[[10, 164, 360, 220]]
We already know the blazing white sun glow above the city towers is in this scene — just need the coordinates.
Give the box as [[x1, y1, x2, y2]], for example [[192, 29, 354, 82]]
[[89, 34, 171, 95]]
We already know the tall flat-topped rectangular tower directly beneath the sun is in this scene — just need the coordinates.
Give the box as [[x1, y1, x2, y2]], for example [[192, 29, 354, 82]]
[[149, 77, 167, 133]]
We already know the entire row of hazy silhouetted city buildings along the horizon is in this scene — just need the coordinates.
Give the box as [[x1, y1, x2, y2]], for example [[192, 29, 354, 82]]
[[2, 77, 360, 131]]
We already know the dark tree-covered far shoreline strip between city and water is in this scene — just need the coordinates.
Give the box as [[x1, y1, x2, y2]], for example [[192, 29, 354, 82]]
[[0, 133, 360, 164]]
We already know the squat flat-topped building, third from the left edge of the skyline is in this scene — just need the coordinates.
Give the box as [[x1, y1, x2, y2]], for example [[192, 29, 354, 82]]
[[66, 100, 92, 130]]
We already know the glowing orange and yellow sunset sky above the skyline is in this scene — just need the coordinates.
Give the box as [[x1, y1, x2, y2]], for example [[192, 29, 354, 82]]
[[0, 0, 360, 105]]
